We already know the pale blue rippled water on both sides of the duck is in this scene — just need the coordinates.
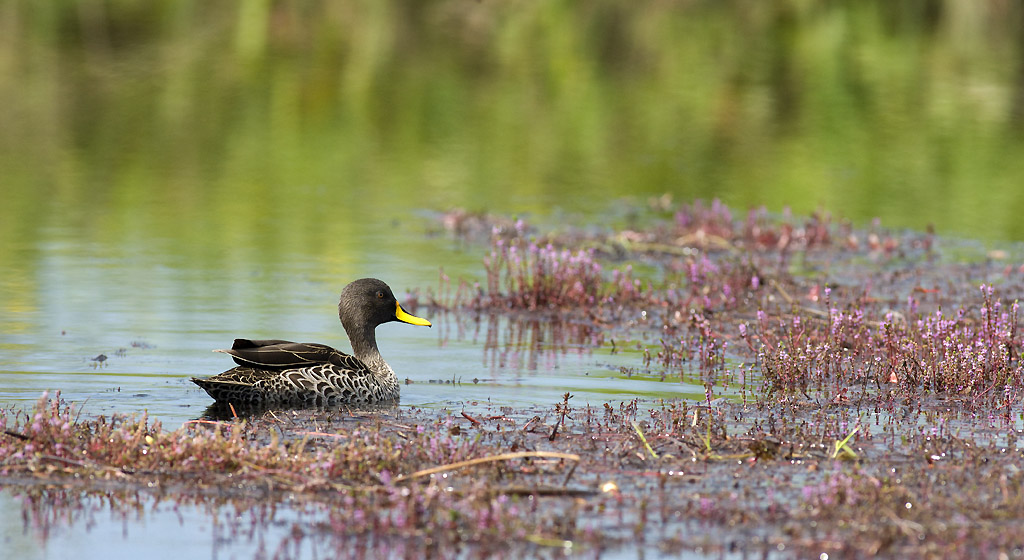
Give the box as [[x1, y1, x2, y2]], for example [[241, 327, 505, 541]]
[[0, 221, 703, 429]]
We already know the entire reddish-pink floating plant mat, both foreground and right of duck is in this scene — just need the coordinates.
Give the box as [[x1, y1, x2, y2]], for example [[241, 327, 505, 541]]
[[6, 204, 1024, 558]]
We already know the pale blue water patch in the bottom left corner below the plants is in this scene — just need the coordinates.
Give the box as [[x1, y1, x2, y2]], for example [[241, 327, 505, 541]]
[[0, 483, 329, 560]]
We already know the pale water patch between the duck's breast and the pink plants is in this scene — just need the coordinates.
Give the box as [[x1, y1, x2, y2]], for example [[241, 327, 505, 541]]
[[409, 310, 705, 406]]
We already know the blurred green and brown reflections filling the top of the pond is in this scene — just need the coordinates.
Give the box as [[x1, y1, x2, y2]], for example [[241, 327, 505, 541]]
[[0, 0, 1024, 298]]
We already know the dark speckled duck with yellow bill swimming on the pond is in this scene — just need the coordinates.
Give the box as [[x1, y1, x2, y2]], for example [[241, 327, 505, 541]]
[[191, 278, 430, 407]]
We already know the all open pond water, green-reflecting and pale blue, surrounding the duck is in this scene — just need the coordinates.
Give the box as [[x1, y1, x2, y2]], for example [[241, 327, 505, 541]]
[[0, 0, 1024, 558]]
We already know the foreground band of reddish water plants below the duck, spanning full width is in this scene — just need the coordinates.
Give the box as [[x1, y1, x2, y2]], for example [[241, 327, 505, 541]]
[[9, 382, 1024, 558]]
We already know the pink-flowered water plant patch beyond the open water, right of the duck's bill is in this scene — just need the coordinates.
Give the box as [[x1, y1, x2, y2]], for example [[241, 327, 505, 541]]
[[424, 199, 1024, 412]]
